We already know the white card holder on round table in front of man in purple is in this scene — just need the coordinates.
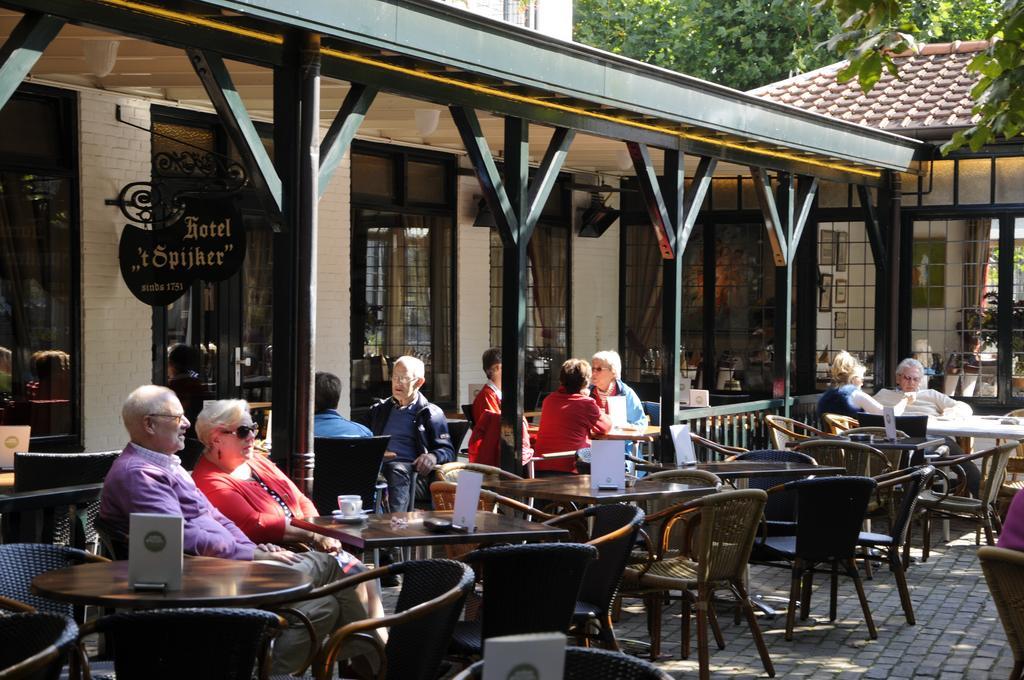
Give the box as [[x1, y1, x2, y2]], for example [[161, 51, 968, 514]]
[[128, 512, 184, 590]]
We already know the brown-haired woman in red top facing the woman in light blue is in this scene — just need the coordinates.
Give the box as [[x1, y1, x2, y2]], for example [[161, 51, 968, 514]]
[[534, 358, 611, 475]]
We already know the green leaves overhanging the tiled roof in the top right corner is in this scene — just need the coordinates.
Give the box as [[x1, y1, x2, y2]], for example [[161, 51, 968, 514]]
[[816, 0, 1003, 153]]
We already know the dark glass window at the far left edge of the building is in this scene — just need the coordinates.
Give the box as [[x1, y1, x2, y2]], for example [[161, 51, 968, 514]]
[[0, 89, 81, 443]]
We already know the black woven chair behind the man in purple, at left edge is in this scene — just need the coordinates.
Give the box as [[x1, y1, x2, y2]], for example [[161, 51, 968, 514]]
[[14, 451, 121, 548]]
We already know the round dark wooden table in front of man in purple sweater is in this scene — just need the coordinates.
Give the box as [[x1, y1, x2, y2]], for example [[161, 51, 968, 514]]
[[32, 557, 313, 606]]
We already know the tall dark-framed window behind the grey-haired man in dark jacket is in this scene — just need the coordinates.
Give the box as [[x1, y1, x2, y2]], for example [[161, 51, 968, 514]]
[[351, 144, 455, 409]]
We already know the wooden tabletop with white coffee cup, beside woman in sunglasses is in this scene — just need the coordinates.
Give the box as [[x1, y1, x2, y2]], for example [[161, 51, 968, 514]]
[[292, 510, 569, 550]]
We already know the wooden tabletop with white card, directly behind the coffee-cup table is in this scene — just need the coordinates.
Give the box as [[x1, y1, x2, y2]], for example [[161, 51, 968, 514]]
[[484, 474, 716, 505]]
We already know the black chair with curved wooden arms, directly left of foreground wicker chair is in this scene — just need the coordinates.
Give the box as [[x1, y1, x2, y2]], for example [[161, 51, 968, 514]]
[[545, 503, 644, 651]]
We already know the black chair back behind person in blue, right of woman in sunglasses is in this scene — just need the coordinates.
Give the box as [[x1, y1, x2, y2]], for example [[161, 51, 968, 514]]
[[310, 435, 391, 515]]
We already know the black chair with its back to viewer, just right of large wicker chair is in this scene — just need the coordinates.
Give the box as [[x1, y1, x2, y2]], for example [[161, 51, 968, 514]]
[[756, 476, 879, 640]]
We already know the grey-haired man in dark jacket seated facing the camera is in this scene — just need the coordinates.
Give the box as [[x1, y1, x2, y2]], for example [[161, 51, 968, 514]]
[[370, 356, 455, 512]]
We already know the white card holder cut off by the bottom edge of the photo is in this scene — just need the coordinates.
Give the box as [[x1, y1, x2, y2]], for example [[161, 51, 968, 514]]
[[482, 633, 565, 680]]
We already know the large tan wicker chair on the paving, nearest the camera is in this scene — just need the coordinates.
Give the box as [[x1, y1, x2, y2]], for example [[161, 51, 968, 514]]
[[624, 488, 775, 680]]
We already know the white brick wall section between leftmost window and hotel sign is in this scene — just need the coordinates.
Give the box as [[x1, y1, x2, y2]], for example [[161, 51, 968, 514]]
[[79, 91, 153, 451]]
